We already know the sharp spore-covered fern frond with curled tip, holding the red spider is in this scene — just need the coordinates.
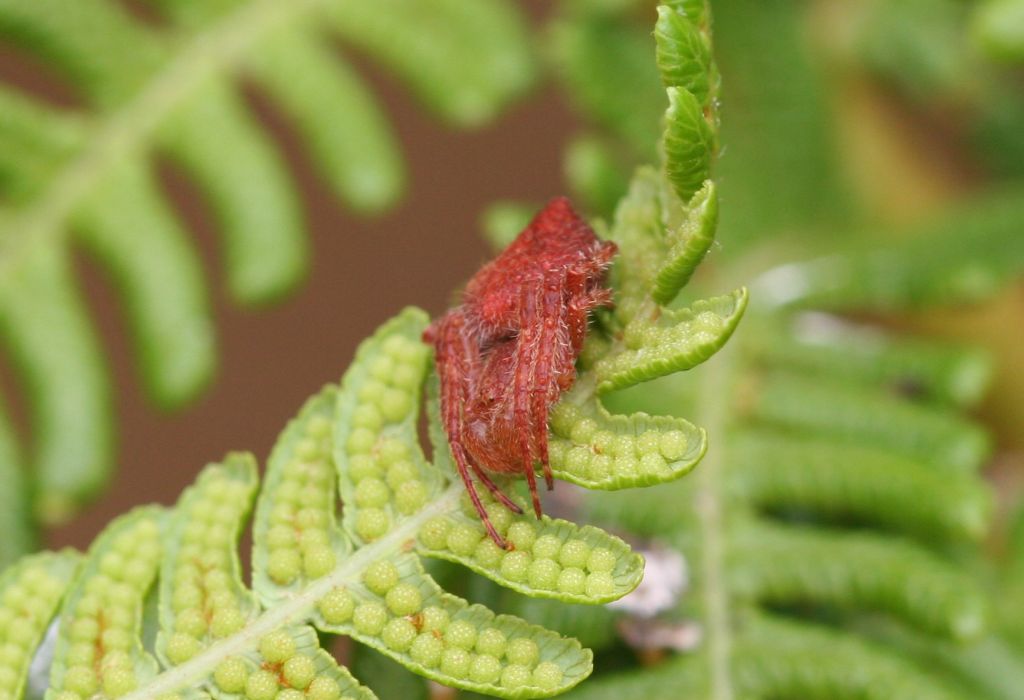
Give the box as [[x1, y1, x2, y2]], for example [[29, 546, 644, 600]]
[[0, 6, 746, 700]]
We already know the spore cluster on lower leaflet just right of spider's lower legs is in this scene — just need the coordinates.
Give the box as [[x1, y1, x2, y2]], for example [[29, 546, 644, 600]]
[[548, 401, 691, 487]]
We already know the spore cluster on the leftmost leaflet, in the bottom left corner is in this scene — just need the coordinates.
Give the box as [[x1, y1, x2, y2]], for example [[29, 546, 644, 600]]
[[0, 554, 66, 700]]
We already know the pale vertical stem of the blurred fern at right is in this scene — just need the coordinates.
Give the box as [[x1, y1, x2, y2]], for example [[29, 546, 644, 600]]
[[694, 339, 735, 700]]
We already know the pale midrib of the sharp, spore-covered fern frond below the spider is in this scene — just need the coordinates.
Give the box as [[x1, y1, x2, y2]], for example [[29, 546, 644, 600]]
[[122, 483, 464, 700]]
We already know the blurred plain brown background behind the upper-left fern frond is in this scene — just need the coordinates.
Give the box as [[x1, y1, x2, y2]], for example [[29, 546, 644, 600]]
[[0, 2, 573, 548]]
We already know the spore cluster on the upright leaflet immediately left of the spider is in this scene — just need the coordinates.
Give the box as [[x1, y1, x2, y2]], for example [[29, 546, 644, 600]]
[[343, 335, 428, 541]]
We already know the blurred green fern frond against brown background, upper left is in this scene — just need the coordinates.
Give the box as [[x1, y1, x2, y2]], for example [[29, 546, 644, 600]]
[[0, 0, 534, 563]]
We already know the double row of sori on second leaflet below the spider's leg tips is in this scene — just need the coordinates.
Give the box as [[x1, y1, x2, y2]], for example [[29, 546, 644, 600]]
[[319, 561, 562, 691]]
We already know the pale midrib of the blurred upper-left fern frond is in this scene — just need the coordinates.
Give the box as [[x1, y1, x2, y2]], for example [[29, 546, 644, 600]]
[[0, 0, 325, 277]]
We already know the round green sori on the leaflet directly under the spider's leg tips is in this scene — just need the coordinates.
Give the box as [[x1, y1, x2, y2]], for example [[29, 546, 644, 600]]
[[420, 489, 616, 599]]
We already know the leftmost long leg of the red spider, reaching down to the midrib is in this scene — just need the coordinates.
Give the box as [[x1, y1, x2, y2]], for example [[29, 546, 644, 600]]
[[435, 314, 507, 549]]
